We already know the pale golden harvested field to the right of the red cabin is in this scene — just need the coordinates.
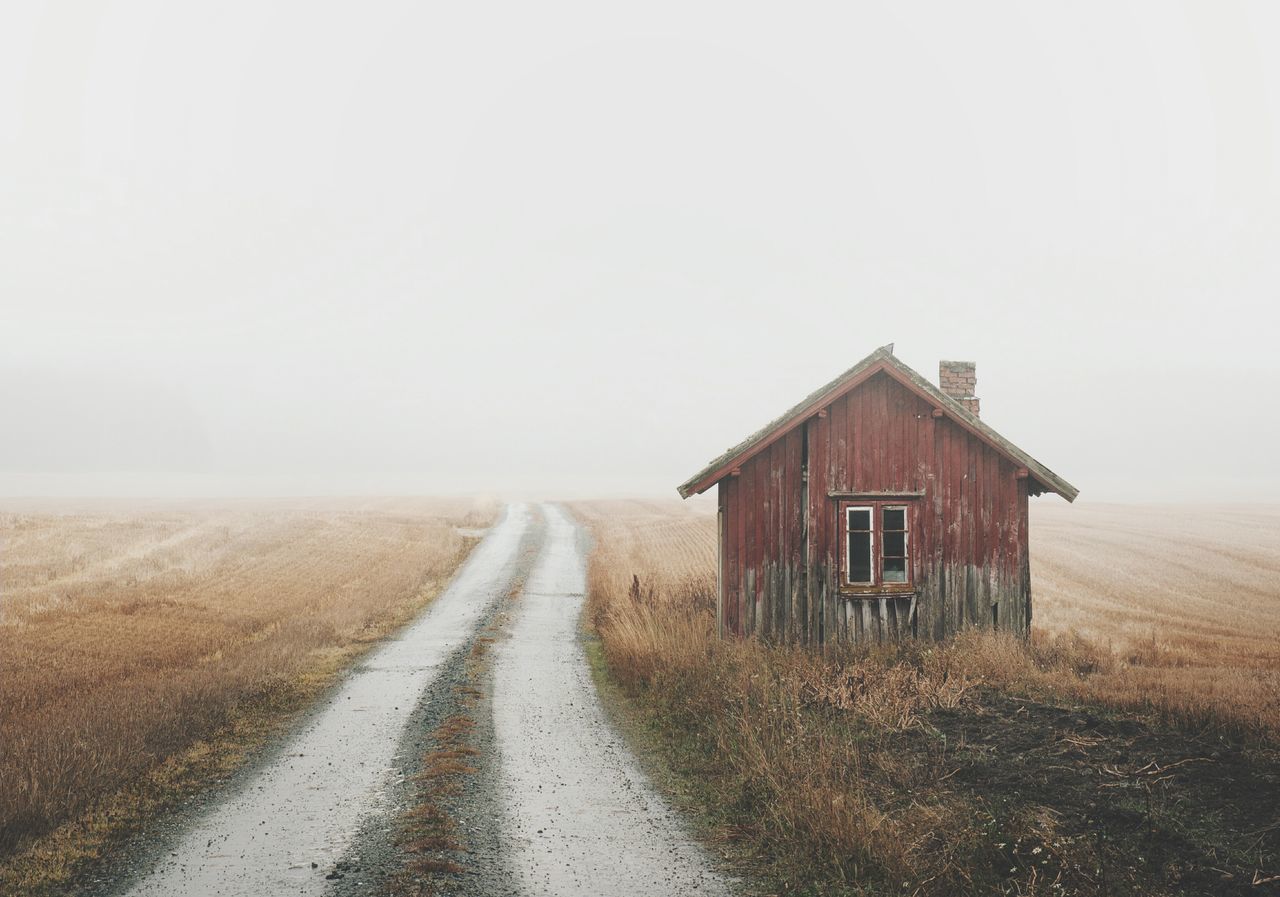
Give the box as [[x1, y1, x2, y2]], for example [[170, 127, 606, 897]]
[[1032, 502, 1280, 733]]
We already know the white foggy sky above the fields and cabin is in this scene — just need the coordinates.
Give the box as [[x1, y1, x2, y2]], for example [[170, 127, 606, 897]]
[[0, 0, 1280, 500]]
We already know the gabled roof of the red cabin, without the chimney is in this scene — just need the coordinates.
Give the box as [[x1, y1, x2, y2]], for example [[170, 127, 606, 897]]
[[678, 343, 1080, 502]]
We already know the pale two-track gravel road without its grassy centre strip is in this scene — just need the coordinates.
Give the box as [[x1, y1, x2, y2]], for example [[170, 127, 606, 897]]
[[114, 505, 730, 897]]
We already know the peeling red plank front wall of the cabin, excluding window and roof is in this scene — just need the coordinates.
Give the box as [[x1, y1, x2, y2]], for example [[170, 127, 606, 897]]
[[719, 374, 1030, 644]]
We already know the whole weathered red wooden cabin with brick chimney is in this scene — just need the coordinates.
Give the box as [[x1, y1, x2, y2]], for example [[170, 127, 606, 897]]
[[680, 345, 1078, 645]]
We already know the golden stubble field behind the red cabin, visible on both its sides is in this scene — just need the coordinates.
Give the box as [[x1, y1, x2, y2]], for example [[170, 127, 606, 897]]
[[575, 502, 1280, 734]]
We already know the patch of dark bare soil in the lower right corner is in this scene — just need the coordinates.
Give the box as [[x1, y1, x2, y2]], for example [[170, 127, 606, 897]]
[[908, 691, 1280, 896]]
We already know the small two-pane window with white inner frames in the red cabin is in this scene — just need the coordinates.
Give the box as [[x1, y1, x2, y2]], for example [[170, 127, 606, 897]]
[[841, 502, 911, 591]]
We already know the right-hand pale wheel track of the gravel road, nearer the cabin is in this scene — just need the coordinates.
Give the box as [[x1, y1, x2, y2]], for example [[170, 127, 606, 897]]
[[493, 505, 731, 897]]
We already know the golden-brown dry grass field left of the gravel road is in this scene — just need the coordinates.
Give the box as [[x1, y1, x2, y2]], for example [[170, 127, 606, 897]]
[[0, 500, 494, 870]]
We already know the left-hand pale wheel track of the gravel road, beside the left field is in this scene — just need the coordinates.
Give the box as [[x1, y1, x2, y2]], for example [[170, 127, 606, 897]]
[[115, 505, 532, 897]]
